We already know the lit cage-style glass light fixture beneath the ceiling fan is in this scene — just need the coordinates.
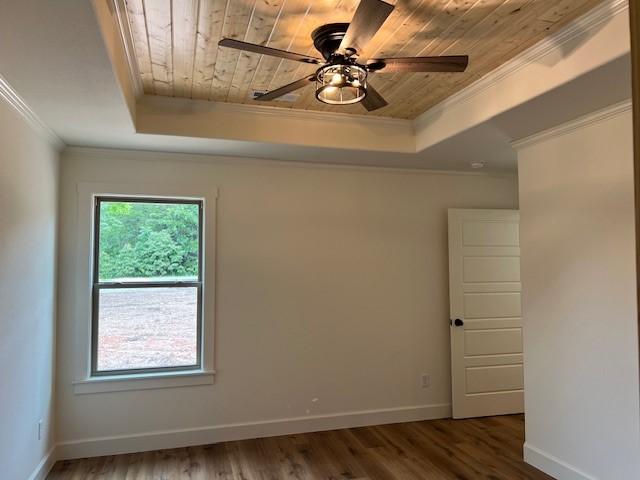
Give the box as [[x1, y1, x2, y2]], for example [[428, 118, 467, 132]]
[[316, 64, 367, 105]]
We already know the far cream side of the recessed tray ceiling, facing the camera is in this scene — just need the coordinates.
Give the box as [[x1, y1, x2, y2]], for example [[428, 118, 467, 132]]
[[135, 95, 416, 153]]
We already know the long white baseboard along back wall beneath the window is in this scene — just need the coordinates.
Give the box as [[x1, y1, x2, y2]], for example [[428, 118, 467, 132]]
[[56, 404, 451, 460]]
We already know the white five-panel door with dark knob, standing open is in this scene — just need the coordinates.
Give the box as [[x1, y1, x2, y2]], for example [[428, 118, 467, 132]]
[[449, 209, 524, 418]]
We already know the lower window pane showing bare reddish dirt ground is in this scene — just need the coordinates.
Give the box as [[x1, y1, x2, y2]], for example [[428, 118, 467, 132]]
[[97, 287, 198, 371]]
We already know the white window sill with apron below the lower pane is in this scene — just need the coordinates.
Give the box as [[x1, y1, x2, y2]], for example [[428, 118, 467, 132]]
[[73, 370, 215, 395]]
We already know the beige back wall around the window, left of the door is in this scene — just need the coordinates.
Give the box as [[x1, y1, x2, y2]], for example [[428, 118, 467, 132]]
[[58, 149, 517, 455]]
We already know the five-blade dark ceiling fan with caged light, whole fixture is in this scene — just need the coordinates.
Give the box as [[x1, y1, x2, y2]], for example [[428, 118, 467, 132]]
[[218, 0, 469, 111]]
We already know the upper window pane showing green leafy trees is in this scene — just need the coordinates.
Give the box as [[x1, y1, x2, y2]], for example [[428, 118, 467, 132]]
[[98, 201, 199, 282]]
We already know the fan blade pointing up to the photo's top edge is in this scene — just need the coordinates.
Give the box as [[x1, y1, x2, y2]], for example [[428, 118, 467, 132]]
[[338, 0, 394, 52]]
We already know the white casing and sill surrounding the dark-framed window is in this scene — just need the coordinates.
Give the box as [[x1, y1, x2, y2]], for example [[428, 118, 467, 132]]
[[73, 183, 218, 394]]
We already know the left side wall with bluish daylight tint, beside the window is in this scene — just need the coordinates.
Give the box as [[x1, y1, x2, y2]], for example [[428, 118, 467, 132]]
[[0, 99, 58, 480]]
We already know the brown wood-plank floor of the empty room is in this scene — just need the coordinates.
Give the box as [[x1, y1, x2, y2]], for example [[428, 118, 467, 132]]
[[47, 415, 551, 480]]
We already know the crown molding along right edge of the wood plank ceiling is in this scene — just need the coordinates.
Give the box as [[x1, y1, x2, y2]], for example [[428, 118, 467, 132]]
[[414, 0, 629, 129]]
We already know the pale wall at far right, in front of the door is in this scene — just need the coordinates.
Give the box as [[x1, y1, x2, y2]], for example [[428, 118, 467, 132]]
[[518, 109, 640, 480]]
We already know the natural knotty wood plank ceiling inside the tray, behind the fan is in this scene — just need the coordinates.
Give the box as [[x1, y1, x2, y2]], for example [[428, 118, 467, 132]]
[[126, 0, 602, 118]]
